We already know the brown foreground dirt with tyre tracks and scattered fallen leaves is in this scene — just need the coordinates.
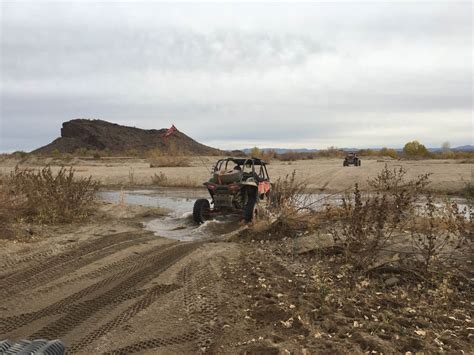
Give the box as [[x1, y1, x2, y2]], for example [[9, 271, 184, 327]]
[[0, 203, 473, 355]]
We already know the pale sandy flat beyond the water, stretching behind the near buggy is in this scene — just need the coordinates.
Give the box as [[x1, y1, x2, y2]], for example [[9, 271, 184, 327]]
[[0, 157, 474, 193]]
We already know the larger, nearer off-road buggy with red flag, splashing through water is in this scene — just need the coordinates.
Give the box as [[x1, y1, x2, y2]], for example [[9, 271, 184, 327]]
[[193, 158, 271, 224]]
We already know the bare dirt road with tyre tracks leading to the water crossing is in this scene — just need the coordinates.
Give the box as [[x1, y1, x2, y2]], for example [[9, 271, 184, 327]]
[[0, 225, 235, 354]]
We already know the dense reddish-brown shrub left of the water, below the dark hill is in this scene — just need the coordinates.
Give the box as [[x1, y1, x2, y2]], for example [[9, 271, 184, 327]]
[[9, 167, 99, 223]]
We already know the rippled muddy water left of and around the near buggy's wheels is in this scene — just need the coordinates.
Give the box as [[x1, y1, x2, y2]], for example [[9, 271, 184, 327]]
[[99, 188, 242, 241]]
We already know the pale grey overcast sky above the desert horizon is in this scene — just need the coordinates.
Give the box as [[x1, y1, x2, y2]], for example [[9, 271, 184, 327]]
[[0, 0, 473, 151]]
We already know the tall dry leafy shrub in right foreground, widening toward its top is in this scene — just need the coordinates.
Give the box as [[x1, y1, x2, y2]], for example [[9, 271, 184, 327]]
[[326, 165, 429, 269]]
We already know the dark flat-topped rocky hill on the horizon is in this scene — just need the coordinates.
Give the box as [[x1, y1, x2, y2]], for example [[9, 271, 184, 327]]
[[32, 119, 225, 155]]
